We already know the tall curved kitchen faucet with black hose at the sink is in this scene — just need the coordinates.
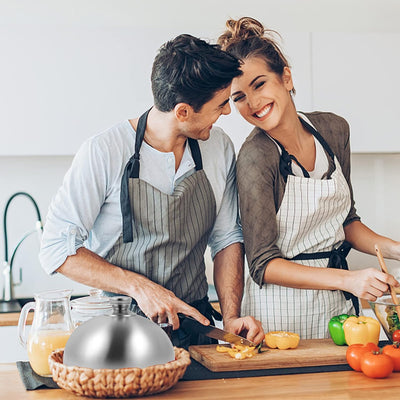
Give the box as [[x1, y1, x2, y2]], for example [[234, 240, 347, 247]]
[[0, 192, 43, 312]]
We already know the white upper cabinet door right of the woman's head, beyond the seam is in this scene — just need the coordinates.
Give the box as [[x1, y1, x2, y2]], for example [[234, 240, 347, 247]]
[[311, 33, 400, 153]]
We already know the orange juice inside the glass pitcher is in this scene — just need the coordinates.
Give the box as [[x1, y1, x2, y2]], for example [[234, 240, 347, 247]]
[[27, 330, 72, 376]]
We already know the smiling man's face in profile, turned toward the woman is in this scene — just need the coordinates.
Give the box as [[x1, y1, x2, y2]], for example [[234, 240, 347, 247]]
[[184, 86, 231, 140]]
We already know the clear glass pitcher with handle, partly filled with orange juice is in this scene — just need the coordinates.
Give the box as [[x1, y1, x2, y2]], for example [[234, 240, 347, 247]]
[[18, 289, 74, 376]]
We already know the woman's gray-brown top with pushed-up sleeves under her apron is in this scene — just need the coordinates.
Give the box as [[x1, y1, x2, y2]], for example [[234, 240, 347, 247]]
[[237, 111, 360, 286]]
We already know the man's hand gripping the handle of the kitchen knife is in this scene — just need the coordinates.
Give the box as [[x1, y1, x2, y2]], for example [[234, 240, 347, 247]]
[[132, 277, 210, 330]]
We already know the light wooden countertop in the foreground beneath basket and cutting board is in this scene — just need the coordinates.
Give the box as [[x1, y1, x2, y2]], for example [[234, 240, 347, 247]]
[[0, 364, 400, 400]]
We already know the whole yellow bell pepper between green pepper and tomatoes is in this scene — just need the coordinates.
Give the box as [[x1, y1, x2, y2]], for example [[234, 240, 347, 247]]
[[343, 315, 381, 346]]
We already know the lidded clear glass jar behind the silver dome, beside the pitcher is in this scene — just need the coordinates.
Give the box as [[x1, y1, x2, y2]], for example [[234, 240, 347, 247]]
[[71, 289, 112, 327]]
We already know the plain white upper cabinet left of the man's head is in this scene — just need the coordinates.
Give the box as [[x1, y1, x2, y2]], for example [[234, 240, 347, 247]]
[[0, 25, 161, 155]]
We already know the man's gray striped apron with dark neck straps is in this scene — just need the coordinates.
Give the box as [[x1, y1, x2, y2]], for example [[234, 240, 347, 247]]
[[105, 110, 216, 346]]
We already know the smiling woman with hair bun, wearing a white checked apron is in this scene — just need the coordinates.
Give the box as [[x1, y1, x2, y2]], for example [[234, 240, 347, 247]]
[[218, 17, 400, 339]]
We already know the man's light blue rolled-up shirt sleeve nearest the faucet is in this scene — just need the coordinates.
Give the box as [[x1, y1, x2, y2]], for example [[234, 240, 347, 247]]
[[39, 140, 107, 274]]
